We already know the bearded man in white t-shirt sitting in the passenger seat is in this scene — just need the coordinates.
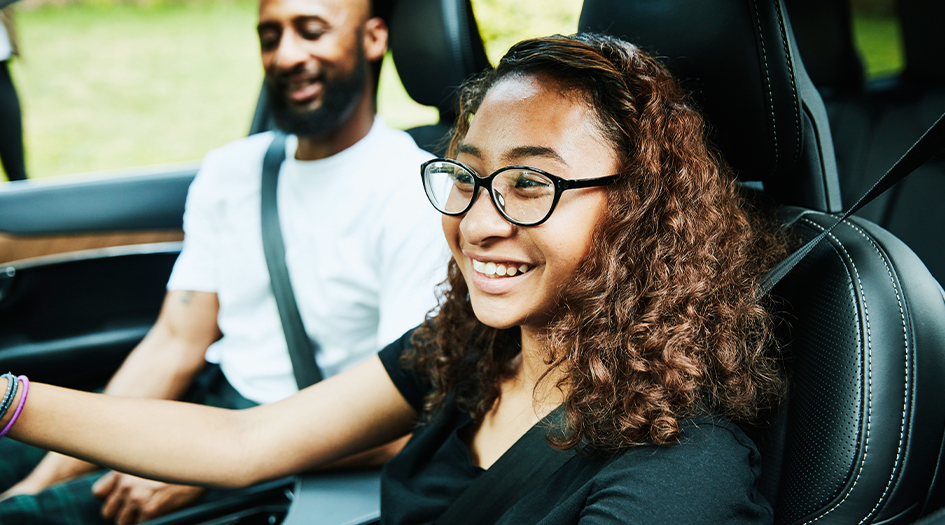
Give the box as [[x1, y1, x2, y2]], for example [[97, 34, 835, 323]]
[[0, 0, 448, 525]]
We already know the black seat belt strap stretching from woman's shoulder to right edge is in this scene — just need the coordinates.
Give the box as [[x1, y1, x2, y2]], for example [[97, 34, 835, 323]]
[[759, 115, 945, 296]]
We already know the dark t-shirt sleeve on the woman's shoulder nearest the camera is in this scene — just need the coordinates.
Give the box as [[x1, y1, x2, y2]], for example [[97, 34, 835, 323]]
[[580, 423, 773, 525]]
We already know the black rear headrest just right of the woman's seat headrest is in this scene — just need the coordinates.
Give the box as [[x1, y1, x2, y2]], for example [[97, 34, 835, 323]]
[[784, 0, 865, 96]]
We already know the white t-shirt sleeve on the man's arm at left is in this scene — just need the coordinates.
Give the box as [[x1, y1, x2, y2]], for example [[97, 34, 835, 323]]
[[167, 152, 222, 292]]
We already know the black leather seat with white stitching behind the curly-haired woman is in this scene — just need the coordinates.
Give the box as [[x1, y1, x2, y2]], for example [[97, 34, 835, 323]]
[[579, 0, 945, 524]]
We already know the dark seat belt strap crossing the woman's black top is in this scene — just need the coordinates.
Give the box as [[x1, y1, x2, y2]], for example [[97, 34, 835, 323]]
[[436, 406, 575, 525]]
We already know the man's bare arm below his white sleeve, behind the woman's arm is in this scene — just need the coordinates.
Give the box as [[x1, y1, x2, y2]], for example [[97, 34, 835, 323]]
[[0, 290, 220, 499]]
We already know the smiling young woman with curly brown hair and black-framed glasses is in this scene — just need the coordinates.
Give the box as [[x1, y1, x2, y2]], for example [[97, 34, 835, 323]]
[[0, 35, 786, 524]]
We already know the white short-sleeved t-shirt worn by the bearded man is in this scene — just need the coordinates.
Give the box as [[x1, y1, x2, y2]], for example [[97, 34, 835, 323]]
[[167, 117, 449, 403]]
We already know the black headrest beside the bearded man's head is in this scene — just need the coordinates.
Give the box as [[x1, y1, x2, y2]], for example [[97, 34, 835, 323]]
[[390, 0, 491, 124]]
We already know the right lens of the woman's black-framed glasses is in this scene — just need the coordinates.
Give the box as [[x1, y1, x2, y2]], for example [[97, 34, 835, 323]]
[[492, 169, 555, 224]]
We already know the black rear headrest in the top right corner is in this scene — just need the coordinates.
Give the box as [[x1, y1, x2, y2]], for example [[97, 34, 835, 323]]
[[898, 0, 945, 83]]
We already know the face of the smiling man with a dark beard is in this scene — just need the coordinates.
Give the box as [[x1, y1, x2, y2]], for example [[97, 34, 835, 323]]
[[258, 0, 370, 136]]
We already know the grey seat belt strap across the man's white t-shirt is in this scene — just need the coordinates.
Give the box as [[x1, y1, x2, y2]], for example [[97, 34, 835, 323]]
[[260, 131, 322, 390]]
